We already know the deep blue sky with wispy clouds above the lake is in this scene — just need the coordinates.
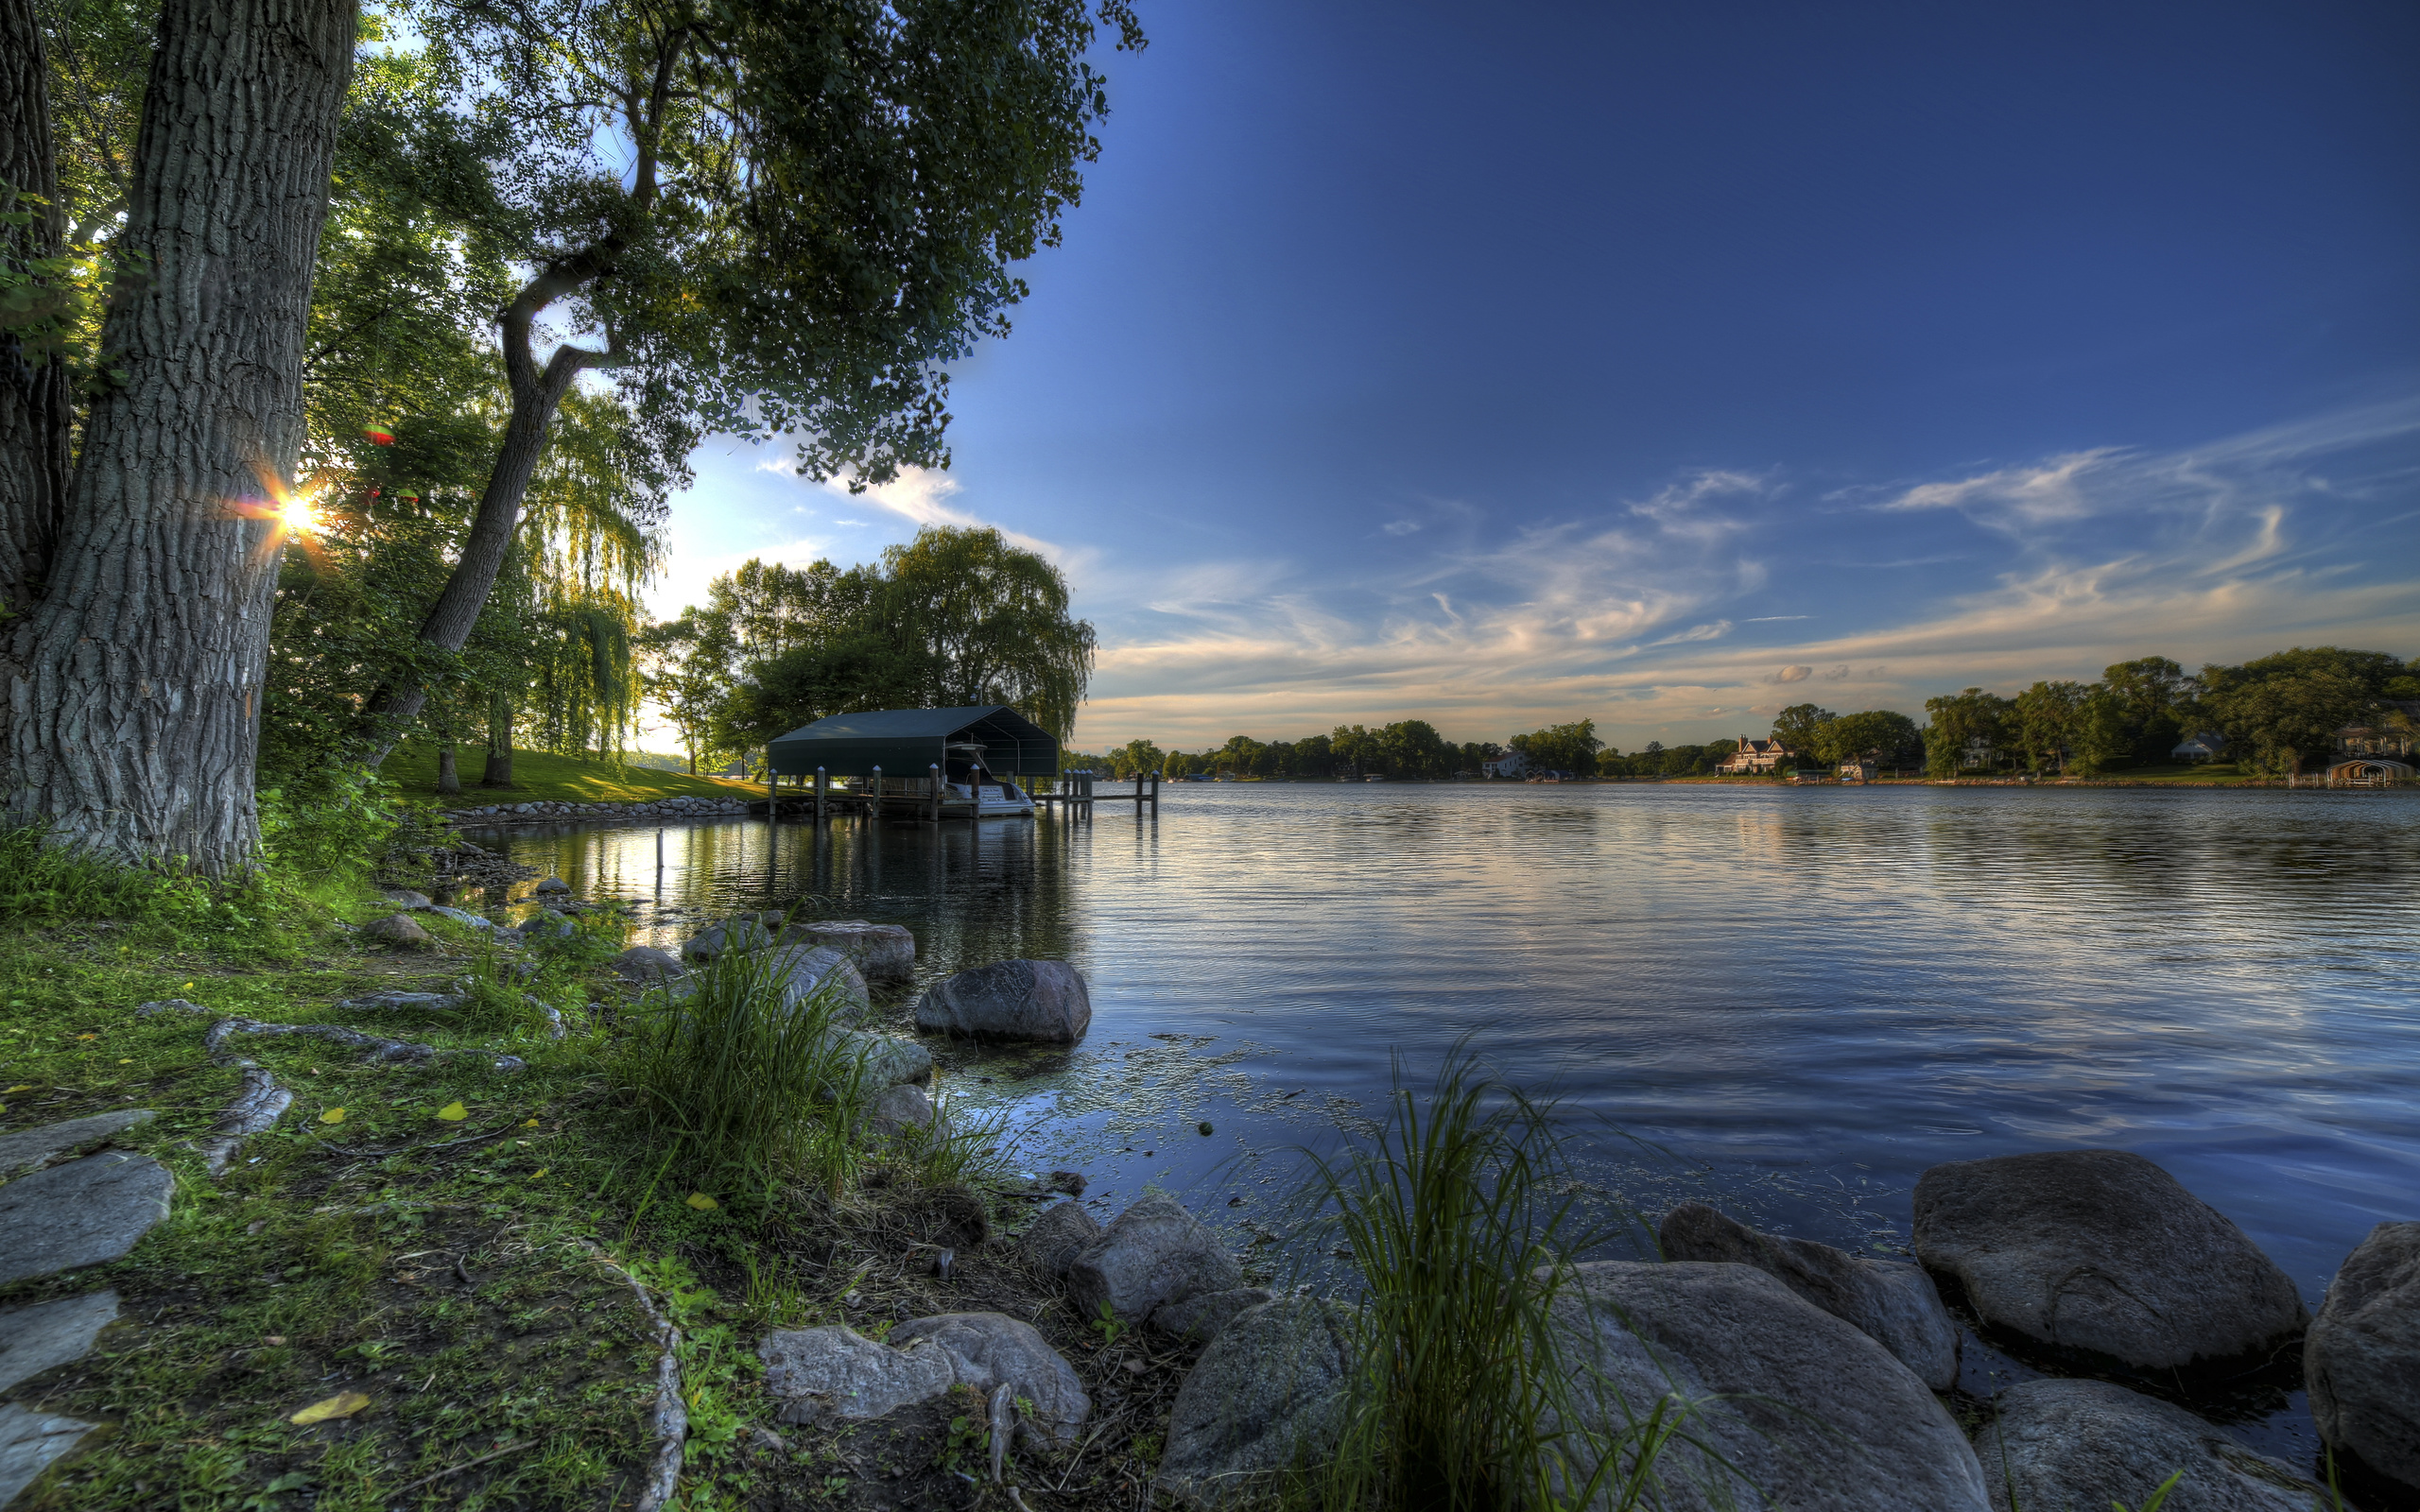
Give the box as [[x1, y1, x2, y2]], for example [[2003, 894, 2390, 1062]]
[[656, 0, 2420, 750]]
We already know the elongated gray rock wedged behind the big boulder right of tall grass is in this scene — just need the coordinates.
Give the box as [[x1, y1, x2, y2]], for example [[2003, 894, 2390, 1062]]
[[1655, 1202, 1958, 1391]]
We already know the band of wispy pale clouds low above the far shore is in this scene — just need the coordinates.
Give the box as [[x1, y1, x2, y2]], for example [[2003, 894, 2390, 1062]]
[[1080, 399, 2420, 743]]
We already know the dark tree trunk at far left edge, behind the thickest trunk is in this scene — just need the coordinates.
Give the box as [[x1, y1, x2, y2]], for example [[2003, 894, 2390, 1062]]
[[0, 0, 75, 612]]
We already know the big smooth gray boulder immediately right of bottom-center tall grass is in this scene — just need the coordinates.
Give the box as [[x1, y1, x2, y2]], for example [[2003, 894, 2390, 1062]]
[[1556, 1261, 1987, 1512]]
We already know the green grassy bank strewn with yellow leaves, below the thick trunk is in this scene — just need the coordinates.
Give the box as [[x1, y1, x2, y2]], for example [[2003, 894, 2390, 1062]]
[[0, 832, 1184, 1512]]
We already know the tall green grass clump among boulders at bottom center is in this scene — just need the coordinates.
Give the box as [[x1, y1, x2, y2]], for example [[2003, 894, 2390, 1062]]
[[1288, 1042, 1694, 1512]]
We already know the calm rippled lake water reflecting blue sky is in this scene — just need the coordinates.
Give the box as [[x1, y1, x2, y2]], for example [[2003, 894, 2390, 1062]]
[[457, 783, 2420, 1449]]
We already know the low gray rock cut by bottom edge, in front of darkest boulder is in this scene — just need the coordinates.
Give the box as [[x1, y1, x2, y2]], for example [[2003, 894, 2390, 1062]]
[[1975, 1379, 2328, 1512]]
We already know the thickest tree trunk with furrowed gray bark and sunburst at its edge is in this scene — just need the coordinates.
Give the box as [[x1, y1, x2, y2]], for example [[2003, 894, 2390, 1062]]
[[0, 0, 355, 876]]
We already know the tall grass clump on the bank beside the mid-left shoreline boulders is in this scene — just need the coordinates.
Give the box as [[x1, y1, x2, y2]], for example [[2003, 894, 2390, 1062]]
[[619, 951, 869, 1195]]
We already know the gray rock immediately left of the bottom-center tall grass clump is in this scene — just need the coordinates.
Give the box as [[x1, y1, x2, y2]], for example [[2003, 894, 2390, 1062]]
[[1154, 1297, 1353, 1507]]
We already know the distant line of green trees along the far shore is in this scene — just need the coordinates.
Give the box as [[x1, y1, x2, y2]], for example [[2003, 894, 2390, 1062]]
[[1063, 646, 2420, 782]]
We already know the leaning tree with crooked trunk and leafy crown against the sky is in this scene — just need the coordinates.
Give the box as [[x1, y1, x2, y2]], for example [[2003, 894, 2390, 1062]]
[[372, 0, 1142, 743]]
